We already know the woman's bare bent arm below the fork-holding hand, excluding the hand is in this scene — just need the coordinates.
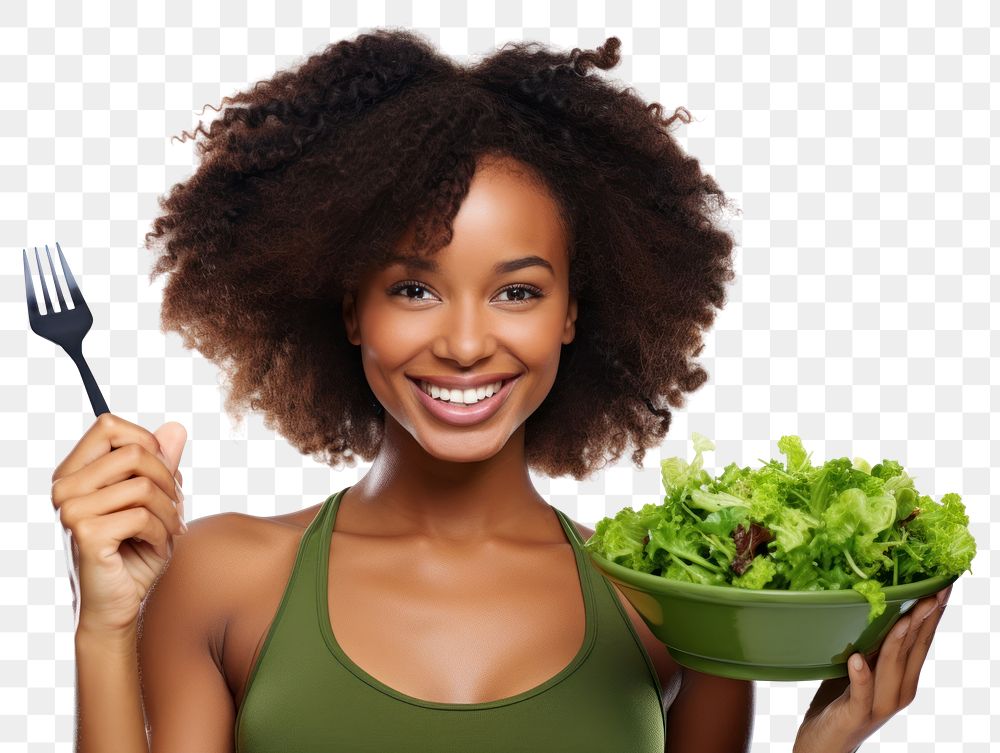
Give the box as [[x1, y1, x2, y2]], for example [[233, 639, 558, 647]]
[[76, 514, 238, 753]]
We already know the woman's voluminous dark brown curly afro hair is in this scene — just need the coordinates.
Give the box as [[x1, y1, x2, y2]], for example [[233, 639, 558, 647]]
[[145, 29, 738, 480]]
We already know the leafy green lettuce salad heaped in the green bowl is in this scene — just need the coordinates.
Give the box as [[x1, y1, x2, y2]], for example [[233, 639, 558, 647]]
[[585, 432, 976, 623]]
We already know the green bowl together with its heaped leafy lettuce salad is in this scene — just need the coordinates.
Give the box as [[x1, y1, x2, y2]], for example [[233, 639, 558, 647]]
[[584, 433, 976, 680]]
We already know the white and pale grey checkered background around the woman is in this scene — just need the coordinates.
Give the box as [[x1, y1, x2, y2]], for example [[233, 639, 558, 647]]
[[0, 0, 1000, 753]]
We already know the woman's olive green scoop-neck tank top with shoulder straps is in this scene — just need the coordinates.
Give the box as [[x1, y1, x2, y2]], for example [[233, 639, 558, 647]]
[[235, 487, 666, 753]]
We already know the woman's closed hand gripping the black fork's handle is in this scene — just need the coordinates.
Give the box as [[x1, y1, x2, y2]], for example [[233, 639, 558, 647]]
[[52, 413, 187, 635]]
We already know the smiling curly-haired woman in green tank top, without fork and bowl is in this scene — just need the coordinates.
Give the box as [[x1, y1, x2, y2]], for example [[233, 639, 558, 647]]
[[58, 30, 940, 753]]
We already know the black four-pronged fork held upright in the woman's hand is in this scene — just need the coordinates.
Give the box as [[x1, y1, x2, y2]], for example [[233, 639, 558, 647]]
[[21, 242, 110, 416]]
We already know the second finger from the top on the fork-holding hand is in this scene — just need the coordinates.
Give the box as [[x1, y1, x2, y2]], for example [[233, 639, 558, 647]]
[[52, 444, 182, 510]]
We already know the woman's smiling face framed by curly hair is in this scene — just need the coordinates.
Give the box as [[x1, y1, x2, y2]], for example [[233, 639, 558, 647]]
[[343, 158, 576, 462]]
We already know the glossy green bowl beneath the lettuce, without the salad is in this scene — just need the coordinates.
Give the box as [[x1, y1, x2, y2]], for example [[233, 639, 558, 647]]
[[589, 552, 958, 680]]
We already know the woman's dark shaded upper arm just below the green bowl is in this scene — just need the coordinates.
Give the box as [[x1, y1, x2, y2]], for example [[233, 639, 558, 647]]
[[664, 668, 754, 753]]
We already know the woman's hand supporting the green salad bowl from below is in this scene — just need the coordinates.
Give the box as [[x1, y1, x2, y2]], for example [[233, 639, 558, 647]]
[[792, 584, 954, 753]]
